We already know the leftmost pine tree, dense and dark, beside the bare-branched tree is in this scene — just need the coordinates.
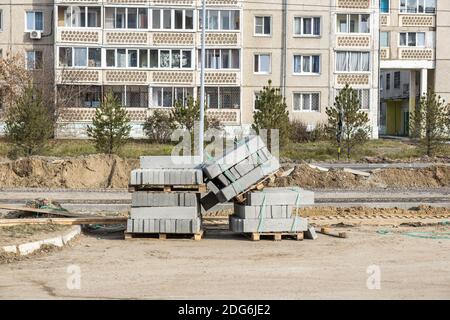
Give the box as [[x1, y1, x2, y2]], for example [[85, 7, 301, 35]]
[[5, 84, 54, 156]]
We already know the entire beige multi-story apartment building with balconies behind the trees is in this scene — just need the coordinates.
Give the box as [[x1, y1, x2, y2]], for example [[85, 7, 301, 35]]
[[0, 0, 450, 138]]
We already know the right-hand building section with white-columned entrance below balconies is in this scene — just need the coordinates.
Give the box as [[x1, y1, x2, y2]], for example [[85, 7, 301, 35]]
[[380, 0, 450, 135]]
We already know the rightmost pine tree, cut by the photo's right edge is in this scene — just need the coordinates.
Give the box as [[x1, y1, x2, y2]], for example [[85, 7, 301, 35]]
[[410, 91, 450, 156]]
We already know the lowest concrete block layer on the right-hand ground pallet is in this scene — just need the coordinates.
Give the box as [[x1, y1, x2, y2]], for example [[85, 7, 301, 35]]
[[230, 215, 308, 233]]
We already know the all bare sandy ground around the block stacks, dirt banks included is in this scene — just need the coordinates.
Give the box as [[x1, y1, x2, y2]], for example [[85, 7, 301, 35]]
[[0, 155, 450, 299]]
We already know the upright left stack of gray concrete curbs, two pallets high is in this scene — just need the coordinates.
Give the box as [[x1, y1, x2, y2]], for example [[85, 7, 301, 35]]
[[127, 157, 203, 234]]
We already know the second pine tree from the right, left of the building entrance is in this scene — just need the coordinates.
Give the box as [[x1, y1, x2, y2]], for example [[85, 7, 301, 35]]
[[326, 84, 370, 159]]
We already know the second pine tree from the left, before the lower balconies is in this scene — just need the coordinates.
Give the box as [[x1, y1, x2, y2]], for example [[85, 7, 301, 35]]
[[87, 91, 131, 154]]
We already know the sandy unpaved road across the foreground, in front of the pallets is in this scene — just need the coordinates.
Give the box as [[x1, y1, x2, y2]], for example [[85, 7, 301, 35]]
[[0, 226, 450, 299]]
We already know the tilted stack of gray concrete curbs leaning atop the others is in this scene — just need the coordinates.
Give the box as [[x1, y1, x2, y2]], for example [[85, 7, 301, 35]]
[[202, 136, 280, 210]]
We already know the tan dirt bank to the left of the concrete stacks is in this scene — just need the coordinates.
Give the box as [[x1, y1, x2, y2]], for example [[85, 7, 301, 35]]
[[0, 154, 139, 189]]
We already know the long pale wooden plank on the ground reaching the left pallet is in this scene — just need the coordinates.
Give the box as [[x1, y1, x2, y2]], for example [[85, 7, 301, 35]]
[[0, 217, 128, 227]]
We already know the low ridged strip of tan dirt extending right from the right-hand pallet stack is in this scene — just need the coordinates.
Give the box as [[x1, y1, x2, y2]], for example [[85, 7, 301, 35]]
[[298, 206, 449, 217]]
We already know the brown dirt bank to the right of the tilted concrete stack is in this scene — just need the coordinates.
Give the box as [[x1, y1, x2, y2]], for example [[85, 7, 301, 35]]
[[270, 164, 450, 189]]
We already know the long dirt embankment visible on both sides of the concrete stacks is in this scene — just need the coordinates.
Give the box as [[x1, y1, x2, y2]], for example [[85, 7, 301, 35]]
[[0, 154, 450, 189]]
